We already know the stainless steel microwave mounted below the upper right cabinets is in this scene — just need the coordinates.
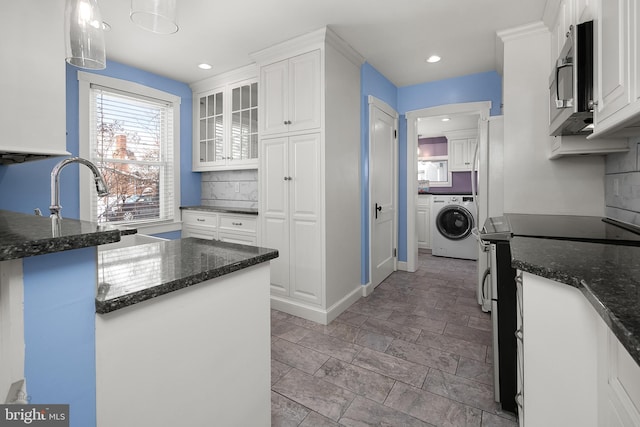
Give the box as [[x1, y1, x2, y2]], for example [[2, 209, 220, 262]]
[[549, 21, 594, 136]]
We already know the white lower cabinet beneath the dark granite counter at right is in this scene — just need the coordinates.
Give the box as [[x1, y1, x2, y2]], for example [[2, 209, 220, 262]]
[[517, 272, 640, 427]]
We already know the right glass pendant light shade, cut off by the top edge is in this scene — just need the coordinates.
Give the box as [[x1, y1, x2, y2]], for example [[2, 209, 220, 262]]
[[129, 0, 178, 34]]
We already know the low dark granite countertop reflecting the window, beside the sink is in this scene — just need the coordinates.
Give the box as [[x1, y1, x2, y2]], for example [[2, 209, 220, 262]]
[[96, 237, 278, 314]]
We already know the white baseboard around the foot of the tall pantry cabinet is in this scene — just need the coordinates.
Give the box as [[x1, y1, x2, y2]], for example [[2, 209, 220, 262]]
[[271, 286, 363, 325]]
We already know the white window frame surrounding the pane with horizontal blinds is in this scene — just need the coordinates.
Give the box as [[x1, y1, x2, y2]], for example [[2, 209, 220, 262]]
[[78, 71, 181, 234]]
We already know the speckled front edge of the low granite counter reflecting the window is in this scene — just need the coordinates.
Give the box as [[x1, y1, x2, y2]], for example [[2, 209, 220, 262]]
[[95, 251, 278, 314]]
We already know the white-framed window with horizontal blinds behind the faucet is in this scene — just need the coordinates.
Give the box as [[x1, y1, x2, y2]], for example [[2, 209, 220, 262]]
[[78, 72, 180, 232]]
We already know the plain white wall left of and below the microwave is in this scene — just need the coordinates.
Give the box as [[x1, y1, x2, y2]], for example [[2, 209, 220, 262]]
[[498, 23, 604, 215]]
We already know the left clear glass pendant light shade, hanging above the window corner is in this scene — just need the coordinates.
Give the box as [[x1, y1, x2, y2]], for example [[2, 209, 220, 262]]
[[64, 0, 107, 70]]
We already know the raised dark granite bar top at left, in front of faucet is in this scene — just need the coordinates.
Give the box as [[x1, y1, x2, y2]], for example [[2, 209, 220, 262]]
[[0, 210, 136, 261]]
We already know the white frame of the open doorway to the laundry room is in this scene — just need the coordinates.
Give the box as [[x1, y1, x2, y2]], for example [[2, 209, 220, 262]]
[[403, 101, 491, 272]]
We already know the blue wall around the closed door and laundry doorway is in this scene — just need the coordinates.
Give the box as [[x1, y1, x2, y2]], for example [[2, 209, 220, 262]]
[[361, 67, 502, 284]]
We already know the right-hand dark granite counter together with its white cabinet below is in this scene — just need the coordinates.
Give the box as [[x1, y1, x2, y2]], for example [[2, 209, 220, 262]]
[[511, 237, 640, 427]]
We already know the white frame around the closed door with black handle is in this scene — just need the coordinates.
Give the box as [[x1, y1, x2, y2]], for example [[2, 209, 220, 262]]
[[363, 95, 400, 296]]
